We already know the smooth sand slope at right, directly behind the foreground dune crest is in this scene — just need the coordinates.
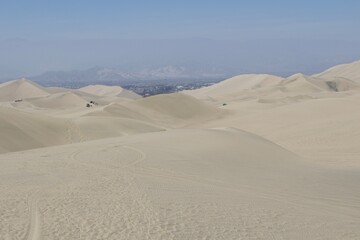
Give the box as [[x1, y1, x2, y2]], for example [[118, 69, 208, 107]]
[[207, 94, 360, 165]]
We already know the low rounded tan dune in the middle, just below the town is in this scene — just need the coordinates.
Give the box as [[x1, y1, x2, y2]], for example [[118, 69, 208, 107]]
[[86, 93, 226, 127]]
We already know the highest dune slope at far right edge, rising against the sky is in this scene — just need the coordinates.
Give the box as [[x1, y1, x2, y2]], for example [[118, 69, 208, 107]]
[[314, 61, 360, 83]]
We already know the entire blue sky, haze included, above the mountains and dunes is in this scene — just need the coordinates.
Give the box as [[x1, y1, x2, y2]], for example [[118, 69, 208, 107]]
[[0, 0, 360, 79]]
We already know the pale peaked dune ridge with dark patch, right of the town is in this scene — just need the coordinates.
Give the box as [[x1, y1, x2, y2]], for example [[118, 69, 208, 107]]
[[184, 73, 359, 105]]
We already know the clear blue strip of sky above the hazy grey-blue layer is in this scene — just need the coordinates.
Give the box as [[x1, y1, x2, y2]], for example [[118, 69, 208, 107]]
[[0, 0, 360, 39]]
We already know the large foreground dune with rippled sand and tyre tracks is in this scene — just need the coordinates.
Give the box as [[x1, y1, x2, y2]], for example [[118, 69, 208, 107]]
[[0, 129, 360, 239]]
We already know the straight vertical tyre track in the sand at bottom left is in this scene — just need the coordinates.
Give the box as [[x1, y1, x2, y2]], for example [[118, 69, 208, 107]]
[[27, 192, 41, 240]]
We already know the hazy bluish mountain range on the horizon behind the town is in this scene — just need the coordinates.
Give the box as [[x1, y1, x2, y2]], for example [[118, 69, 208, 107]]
[[29, 66, 229, 87]]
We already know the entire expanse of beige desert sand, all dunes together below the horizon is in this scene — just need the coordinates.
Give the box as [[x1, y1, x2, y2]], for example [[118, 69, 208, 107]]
[[0, 62, 360, 240]]
